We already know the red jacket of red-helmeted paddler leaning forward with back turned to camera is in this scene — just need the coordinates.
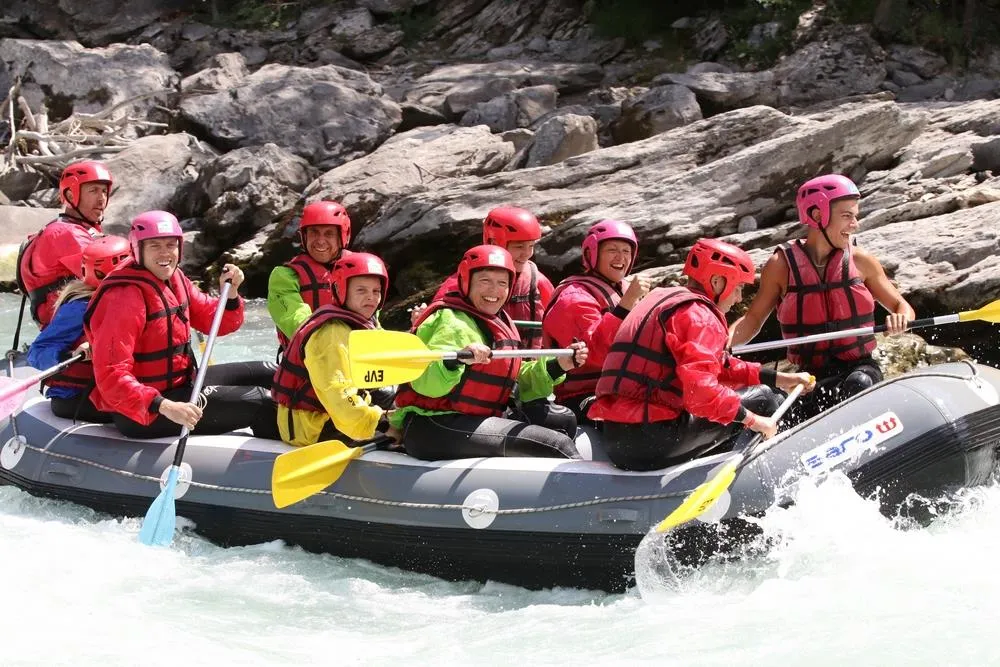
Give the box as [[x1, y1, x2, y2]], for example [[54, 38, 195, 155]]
[[587, 287, 760, 424]]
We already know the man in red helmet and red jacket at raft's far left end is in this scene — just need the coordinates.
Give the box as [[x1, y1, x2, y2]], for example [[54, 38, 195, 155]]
[[17, 160, 112, 329]]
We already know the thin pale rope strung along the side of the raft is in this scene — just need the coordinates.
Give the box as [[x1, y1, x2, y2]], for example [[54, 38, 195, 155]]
[[7, 366, 979, 516]]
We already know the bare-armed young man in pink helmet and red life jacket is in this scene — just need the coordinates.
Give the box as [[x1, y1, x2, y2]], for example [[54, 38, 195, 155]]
[[731, 174, 916, 413]]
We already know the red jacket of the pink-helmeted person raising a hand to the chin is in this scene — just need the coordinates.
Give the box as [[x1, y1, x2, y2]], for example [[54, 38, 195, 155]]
[[542, 274, 628, 400]]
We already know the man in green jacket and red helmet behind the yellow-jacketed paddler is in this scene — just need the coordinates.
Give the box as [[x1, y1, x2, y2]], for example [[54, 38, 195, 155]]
[[267, 201, 351, 352]]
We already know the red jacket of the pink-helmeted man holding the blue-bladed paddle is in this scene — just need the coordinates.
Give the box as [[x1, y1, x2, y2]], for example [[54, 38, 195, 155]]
[[84, 262, 243, 425]]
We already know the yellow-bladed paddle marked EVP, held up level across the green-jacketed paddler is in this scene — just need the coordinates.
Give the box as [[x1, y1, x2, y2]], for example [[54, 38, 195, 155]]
[[347, 329, 575, 389]]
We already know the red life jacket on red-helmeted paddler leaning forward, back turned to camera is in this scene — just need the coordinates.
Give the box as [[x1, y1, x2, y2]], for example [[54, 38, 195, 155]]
[[597, 287, 728, 423]]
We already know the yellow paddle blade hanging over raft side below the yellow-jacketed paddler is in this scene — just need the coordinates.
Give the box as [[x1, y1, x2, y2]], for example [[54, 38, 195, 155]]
[[271, 433, 393, 508]]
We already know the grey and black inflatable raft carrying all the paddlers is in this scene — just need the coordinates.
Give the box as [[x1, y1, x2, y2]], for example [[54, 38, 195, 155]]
[[0, 363, 1000, 591]]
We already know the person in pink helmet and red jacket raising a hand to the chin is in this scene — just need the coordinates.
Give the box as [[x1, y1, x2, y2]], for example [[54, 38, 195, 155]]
[[542, 220, 649, 421]]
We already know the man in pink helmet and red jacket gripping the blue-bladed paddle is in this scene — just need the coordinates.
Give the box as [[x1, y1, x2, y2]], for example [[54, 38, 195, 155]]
[[84, 211, 277, 438]]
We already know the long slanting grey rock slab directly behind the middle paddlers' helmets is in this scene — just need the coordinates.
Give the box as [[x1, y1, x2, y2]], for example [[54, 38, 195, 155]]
[[358, 103, 925, 272]]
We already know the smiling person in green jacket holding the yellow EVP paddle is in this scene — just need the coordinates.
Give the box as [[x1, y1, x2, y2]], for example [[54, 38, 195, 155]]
[[389, 245, 587, 460]]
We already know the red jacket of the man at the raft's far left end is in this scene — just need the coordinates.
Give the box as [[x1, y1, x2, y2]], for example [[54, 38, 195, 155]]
[[17, 214, 101, 329]]
